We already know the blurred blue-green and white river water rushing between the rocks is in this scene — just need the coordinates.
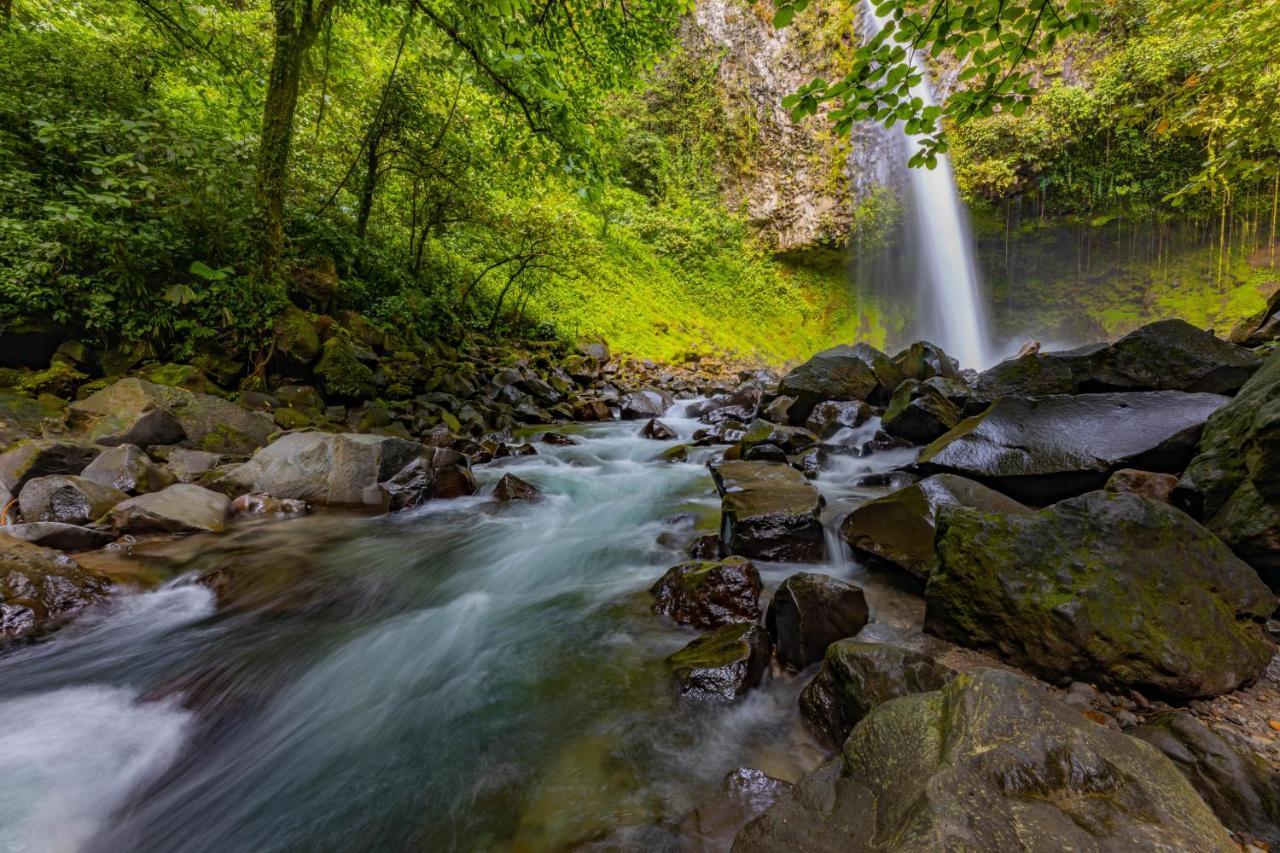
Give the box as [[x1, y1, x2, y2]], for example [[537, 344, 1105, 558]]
[[0, 405, 920, 853]]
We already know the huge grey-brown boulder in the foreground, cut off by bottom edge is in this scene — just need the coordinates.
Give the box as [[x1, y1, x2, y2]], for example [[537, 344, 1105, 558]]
[[733, 669, 1238, 853]]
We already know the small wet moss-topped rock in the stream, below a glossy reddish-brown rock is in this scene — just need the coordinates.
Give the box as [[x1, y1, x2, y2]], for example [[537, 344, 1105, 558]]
[[667, 622, 769, 702]]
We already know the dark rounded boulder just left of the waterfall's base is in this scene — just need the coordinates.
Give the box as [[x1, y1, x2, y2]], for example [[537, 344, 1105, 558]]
[[778, 343, 901, 424]]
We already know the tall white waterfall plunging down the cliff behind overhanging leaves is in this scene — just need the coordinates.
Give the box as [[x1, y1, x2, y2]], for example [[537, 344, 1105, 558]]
[[860, 3, 991, 369]]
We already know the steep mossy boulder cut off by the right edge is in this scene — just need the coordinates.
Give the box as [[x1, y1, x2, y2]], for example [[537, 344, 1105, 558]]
[[1174, 351, 1280, 589]]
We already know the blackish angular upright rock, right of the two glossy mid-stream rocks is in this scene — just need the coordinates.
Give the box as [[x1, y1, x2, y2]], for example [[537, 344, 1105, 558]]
[[764, 571, 869, 670]]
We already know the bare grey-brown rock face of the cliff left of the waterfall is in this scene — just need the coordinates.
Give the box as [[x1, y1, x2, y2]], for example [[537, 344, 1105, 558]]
[[682, 0, 854, 251]]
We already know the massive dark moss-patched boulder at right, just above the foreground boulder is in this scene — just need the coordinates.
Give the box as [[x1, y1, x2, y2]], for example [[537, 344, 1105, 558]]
[[924, 492, 1276, 699]]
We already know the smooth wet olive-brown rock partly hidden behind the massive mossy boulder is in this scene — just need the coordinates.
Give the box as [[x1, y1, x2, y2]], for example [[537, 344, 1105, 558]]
[[840, 474, 1030, 580]]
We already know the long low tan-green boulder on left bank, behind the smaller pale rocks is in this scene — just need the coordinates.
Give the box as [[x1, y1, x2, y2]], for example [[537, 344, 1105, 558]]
[[70, 378, 276, 453]]
